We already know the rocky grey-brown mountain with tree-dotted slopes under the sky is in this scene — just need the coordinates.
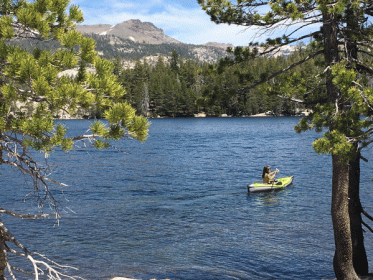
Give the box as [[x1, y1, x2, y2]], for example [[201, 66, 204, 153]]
[[76, 19, 234, 65]]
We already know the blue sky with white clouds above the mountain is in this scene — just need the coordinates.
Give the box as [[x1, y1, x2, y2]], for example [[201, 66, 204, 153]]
[[71, 0, 268, 46]]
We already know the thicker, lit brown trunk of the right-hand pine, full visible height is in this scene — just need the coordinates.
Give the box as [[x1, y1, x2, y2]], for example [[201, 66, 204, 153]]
[[322, 8, 359, 280]]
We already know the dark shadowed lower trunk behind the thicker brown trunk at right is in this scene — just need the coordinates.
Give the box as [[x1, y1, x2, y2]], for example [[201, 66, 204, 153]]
[[348, 150, 368, 275]]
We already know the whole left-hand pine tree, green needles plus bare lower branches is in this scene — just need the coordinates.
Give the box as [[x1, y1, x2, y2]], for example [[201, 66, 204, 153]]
[[0, 0, 148, 280]]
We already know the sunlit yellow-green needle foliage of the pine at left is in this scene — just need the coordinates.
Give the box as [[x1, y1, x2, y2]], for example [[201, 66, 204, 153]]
[[0, 0, 148, 160]]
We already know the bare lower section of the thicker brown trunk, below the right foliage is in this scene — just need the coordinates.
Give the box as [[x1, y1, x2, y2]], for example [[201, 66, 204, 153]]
[[332, 155, 359, 280]]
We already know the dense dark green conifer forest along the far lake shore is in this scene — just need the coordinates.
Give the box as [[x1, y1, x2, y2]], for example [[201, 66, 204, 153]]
[[115, 50, 305, 117]]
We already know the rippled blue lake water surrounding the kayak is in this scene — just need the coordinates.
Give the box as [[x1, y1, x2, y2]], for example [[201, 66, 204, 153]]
[[0, 118, 373, 279]]
